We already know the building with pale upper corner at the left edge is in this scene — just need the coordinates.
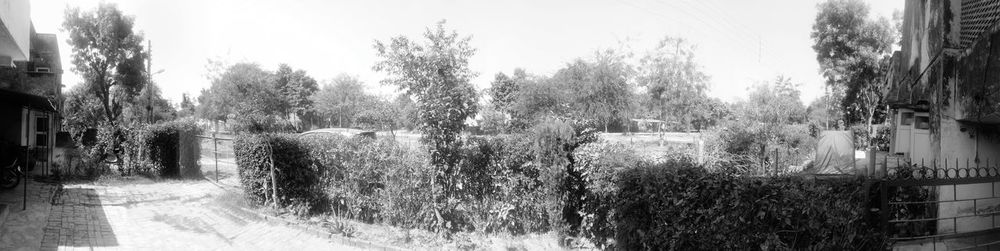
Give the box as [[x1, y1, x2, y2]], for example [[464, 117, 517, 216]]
[[0, 0, 62, 176]]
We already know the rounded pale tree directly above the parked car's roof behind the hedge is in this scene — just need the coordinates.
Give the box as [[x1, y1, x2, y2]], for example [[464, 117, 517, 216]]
[[309, 74, 370, 127]]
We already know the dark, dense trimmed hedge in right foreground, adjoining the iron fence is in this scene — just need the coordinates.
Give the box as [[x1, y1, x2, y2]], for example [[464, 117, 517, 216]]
[[612, 159, 885, 250]]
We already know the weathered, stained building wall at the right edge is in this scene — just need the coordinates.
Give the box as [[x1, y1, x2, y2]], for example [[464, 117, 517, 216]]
[[888, 0, 1000, 233]]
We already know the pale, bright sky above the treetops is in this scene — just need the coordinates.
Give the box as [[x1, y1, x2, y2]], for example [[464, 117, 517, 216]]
[[31, 0, 904, 104]]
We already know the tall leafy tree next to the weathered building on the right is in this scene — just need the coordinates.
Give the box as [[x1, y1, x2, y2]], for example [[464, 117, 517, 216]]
[[810, 0, 897, 123]]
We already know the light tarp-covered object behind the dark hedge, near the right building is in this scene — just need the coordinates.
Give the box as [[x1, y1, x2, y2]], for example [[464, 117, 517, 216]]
[[811, 131, 854, 174]]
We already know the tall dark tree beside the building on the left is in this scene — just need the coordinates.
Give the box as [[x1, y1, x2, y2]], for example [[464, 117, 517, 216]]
[[63, 3, 146, 127]]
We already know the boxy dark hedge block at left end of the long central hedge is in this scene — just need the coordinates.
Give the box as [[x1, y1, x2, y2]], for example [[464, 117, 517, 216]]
[[233, 134, 325, 210]]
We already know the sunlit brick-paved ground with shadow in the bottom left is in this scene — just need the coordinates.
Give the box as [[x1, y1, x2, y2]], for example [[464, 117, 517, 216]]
[[0, 177, 360, 250]]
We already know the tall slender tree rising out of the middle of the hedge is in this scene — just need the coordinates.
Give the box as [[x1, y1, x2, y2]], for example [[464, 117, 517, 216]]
[[373, 21, 478, 230]]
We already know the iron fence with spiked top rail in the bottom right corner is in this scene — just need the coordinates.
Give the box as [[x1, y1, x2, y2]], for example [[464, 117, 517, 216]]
[[878, 158, 1000, 250]]
